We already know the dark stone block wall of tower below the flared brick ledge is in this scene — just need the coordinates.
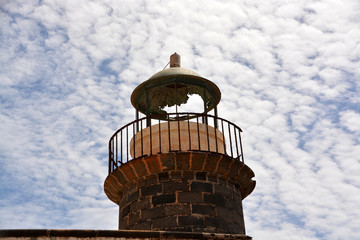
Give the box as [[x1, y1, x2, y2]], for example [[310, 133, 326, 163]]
[[119, 171, 244, 233]]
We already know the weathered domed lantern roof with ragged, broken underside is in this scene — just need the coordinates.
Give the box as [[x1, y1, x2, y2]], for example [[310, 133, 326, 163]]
[[131, 67, 221, 115]]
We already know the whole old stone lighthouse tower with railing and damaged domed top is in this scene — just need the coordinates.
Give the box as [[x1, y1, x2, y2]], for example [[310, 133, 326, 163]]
[[104, 53, 255, 236]]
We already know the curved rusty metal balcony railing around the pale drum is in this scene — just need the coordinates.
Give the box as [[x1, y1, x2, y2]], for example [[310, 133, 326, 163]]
[[109, 113, 244, 174]]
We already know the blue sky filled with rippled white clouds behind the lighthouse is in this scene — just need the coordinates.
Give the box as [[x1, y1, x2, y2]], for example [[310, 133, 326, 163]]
[[0, 0, 360, 240]]
